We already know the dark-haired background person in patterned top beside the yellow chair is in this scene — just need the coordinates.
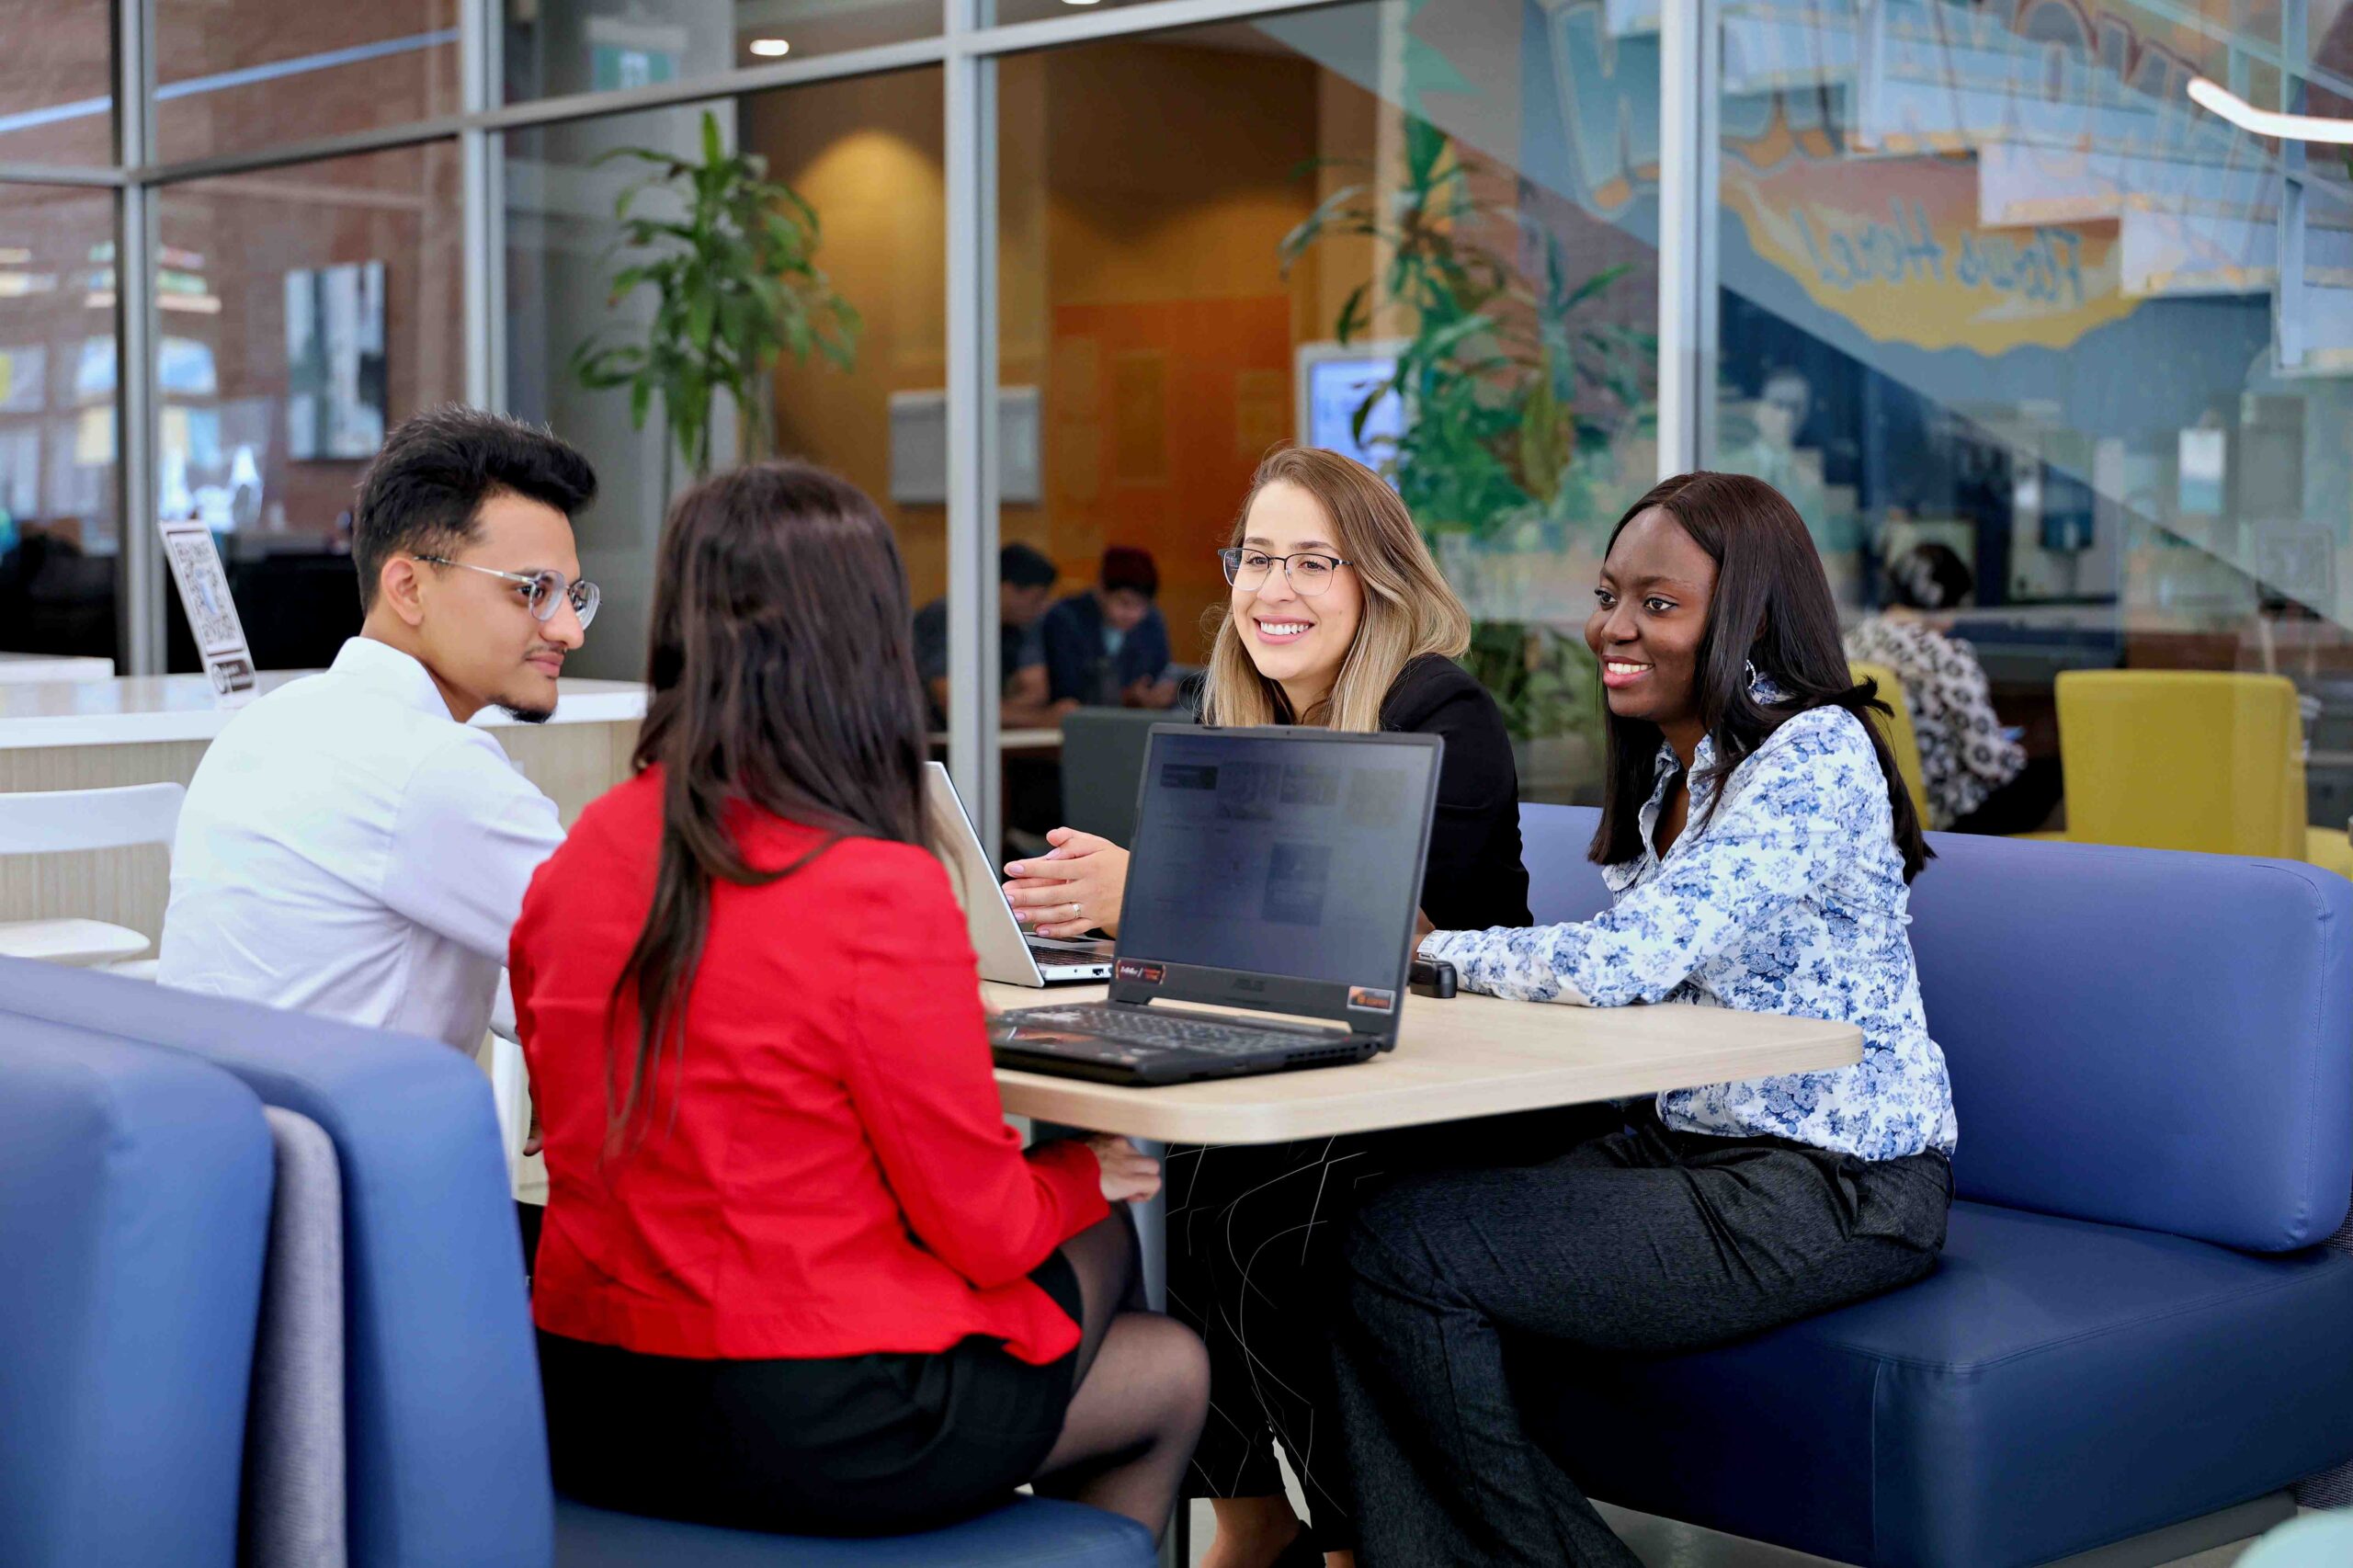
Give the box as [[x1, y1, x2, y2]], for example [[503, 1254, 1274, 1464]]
[[1845, 544, 2059, 834]]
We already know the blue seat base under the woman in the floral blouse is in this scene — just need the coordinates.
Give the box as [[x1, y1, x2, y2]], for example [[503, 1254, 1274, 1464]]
[[1516, 1203, 2353, 1568]]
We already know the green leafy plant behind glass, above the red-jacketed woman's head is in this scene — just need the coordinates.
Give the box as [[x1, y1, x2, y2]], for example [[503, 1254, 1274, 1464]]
[[572, 110, 861, 478]]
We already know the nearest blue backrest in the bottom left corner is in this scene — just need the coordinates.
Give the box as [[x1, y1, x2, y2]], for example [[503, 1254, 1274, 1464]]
[[0, 1012, 276, 1568]]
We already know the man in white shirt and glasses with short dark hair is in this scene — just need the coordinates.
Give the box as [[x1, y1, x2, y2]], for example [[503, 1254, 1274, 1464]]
[[158, 407, 597, 1055]]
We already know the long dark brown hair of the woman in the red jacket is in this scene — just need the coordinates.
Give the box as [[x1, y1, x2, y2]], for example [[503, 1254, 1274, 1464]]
[[605, 464, 929, 1152]]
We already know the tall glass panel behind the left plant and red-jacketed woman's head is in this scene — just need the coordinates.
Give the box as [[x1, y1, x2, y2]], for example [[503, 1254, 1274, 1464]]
[[506, 68, 946, 680]]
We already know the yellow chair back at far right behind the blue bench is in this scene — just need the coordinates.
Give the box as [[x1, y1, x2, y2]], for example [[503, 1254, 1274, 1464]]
[[2059, 668, 2353, 876]]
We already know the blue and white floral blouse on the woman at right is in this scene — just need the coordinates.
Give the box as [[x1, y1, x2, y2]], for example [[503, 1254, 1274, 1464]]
[[1421, 690, 1955, 1161]]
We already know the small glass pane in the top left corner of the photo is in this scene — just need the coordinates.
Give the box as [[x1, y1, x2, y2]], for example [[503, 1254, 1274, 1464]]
[[0, 0, 115, 167]]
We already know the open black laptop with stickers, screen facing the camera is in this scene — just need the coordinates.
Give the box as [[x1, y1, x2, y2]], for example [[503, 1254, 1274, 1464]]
[[993, 725, 1442, 1085]]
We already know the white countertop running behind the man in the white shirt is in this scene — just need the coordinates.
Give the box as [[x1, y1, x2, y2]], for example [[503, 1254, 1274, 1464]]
[[0, 671, 644, 751]]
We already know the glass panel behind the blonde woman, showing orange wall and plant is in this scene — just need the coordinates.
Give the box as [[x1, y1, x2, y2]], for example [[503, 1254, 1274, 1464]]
[[997, 0, 1659, 805]]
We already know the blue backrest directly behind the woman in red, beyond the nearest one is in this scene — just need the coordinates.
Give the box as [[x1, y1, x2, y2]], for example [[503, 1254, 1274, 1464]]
[[0, 959, 553, 1568]]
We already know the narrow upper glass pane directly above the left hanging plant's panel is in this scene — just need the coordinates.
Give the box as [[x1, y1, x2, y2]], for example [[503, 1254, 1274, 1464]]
[[504, 0, 944, 104]]
